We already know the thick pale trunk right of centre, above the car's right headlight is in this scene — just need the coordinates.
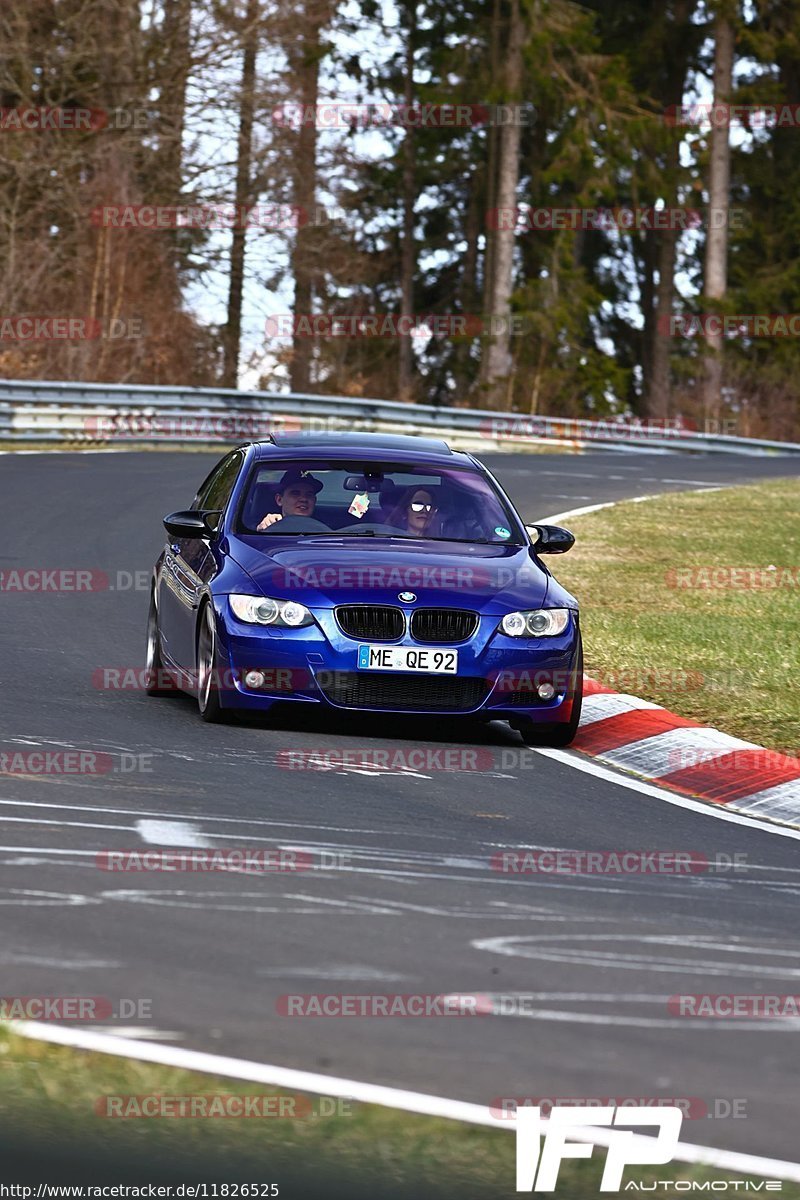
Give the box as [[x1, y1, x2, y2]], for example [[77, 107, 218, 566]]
[[482, 0, 523, 408]]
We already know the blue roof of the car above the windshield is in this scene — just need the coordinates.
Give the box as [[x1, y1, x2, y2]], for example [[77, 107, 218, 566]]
[[252, 431, 475, 467]]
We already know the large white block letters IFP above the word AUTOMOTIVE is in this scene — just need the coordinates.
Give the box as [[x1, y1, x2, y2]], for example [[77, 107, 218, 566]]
[[517, 1105, 684, 1192]]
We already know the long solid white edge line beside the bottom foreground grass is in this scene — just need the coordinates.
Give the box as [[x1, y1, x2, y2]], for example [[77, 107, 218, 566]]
[[14, 1021, 800, 1183]]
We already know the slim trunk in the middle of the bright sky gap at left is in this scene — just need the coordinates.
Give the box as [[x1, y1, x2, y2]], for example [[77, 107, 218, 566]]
[[222, 0, 259, 388]]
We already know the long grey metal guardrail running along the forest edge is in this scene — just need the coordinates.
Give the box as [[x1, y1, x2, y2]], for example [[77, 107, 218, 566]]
[[0, 380, 800, 456]]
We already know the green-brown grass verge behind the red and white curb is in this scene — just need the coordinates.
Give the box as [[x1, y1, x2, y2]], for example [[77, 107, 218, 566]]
[[557, 480, 800, 755]]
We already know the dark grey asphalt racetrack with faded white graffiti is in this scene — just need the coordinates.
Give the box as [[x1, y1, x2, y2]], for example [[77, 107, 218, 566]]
[[0, 452, 800, 1159]]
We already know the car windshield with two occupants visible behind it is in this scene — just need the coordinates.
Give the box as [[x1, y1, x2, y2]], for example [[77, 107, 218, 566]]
[[239, 460, 525, 546]]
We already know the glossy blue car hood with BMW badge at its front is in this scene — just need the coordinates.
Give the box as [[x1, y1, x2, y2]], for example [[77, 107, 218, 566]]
[[229, 535, 568, 614]]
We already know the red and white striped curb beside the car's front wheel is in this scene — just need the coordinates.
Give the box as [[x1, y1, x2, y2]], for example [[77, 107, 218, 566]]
[[571, 676, 800, 828]]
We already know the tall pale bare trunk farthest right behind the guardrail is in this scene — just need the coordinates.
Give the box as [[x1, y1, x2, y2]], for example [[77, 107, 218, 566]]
[[703, 8, 734, 420]]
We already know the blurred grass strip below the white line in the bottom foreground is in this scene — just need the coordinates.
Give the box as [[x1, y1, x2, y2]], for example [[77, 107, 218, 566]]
[[0, 1027, 800, 1200]]
